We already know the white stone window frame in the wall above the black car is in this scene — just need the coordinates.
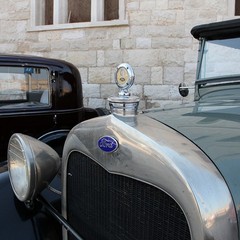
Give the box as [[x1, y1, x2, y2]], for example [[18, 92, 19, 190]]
[[29, 0, 128, 31]]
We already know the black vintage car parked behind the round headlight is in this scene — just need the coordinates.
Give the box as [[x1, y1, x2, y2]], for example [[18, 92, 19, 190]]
[[0, 55, 105, 161]]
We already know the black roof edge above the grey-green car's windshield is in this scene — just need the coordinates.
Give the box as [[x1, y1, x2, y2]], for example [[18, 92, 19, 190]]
[[191, 19, 240, 40]]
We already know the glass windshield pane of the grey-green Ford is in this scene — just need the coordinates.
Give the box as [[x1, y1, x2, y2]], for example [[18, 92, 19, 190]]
[[198, 38, 240, 80]]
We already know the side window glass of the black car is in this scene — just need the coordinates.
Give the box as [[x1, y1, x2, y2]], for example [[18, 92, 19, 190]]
[[0, 66, 50, 109]]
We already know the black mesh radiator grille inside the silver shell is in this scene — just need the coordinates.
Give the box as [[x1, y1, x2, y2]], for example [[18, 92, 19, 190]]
[[67, 152, 191, 240]]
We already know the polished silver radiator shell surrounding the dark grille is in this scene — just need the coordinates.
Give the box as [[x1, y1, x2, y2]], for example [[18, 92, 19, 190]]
[[62, 115, 238, 240]]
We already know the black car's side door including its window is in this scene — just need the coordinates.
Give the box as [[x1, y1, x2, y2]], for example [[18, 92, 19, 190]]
[[0, 64, 55, 161]]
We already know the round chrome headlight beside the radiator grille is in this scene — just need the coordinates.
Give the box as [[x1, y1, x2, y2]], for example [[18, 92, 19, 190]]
[[8, 133, 60, 201]]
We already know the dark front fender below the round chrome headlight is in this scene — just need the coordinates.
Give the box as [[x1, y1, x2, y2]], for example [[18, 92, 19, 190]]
[[0, 164, 61, 240]]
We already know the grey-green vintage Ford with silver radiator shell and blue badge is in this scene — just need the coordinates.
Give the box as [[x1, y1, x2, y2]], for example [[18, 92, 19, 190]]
[[0, 20, 240, 240]]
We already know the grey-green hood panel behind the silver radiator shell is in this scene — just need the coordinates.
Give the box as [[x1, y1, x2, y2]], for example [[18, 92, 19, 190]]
[[146, 102, 240, 217]]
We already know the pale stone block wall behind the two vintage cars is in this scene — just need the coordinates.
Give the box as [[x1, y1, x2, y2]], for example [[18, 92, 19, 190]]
[[0, 0, 234, 108]]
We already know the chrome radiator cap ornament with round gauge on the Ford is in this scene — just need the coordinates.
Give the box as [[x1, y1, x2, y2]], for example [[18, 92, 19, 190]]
[[108, 63, 140, 117]]
